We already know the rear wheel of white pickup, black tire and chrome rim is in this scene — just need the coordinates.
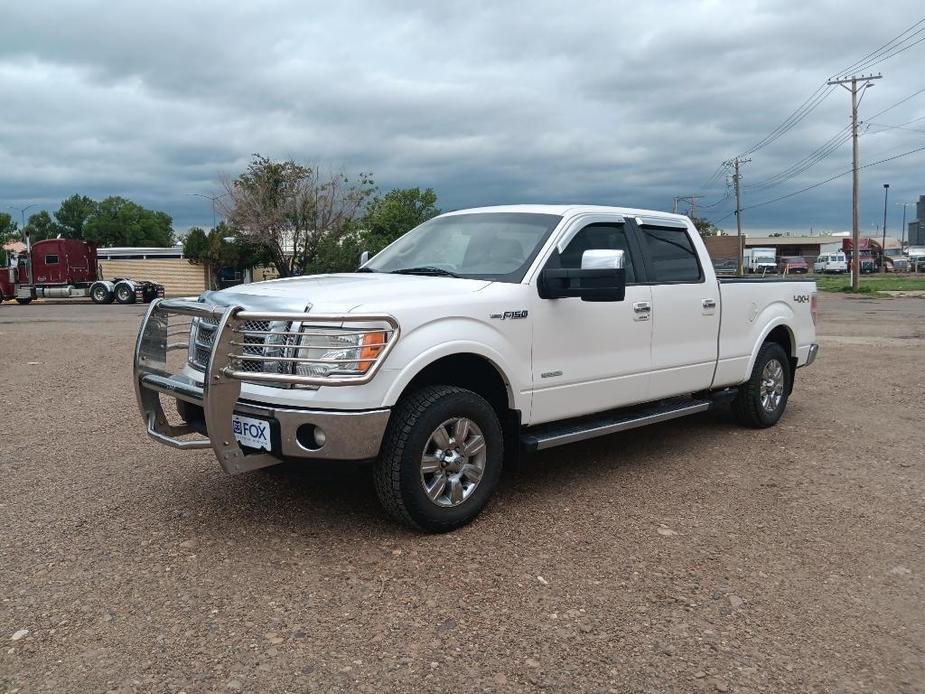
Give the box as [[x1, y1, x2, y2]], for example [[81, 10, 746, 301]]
[[732, 342, 793, 429]]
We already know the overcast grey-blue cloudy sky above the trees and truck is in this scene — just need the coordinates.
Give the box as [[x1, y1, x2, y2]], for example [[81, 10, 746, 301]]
[[0, 0, 925, 237]]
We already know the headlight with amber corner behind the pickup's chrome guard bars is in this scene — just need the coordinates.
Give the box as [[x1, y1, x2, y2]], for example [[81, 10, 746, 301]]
[[295, 326, 387, 377]]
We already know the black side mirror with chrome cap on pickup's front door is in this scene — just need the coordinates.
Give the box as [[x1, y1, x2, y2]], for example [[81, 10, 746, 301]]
[[539, 249, 626, 301]]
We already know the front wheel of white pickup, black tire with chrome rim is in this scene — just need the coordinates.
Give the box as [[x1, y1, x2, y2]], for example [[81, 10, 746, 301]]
[[374, 386, 504, 532]]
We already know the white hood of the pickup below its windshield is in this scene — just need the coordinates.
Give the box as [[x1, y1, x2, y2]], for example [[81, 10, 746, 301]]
[[202, 272, 491, 313]]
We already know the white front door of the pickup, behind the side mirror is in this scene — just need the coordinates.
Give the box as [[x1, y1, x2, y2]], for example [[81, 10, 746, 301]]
[[530, 218, 652, 424]]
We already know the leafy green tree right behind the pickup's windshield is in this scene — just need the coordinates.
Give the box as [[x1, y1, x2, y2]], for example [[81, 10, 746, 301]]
[[360, 188, 440, 253]]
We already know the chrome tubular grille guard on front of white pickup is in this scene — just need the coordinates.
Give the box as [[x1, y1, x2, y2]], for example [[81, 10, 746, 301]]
[[133, 299, 399, 474]]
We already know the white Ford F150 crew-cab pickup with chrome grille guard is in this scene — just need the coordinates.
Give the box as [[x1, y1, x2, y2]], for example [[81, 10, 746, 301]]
[[134, 205, 818, 532]]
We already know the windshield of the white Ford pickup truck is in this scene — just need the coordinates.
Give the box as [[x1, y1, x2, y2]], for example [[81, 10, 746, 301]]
[[363, 212, 562, 282]]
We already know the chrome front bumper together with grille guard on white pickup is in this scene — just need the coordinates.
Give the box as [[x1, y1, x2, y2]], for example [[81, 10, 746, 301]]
[[134, 300, 398, 474]]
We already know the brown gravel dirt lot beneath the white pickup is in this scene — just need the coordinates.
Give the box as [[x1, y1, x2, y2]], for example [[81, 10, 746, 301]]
[[0, 295, 925, 693]]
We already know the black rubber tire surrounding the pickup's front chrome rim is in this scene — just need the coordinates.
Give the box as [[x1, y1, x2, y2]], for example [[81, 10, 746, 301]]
[[373, 386, 504, 533]]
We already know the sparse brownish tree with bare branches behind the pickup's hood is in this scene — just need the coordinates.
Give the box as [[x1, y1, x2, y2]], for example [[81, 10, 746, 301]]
[[223, 154, 375, 277]]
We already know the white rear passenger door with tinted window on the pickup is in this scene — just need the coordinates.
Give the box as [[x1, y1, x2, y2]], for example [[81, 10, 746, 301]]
[[635, 218, 720, 400]]
